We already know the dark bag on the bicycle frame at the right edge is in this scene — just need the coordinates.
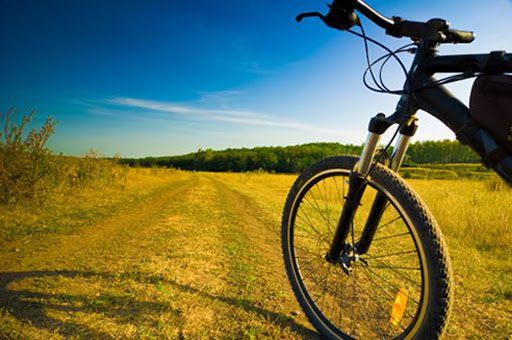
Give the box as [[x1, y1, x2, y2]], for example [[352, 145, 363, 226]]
[[469, 74, 512, 152]]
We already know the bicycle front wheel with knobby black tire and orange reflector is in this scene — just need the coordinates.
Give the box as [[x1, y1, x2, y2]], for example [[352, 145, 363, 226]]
[[282, 156, 451, 339]]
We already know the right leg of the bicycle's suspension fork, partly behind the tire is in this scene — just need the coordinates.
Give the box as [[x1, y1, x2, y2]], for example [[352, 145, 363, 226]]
[[355, 118, 418, 254]]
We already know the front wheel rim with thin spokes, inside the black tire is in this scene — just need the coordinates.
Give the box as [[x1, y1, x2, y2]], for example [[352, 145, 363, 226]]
[[288, 169, 428, 338]]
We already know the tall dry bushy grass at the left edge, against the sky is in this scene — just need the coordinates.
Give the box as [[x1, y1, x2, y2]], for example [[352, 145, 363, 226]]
[[0, 108, 127, 205]]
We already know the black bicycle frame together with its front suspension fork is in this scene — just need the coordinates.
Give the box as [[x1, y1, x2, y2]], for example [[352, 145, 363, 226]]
[[326, 41, 512, 262]]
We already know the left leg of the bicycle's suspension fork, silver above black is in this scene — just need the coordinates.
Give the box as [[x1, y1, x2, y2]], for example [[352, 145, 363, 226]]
[[326, 113, 392, 263]]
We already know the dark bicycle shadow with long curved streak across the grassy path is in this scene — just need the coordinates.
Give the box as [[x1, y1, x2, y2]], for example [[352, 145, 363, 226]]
[[0, 271, 318, 338]]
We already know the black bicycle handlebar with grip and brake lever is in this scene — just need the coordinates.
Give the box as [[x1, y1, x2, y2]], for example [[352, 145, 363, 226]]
[[297, 0, 475, 43]]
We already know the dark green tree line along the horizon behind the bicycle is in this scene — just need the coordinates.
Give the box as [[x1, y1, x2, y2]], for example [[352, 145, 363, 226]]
[[121, 140, 479, 173]]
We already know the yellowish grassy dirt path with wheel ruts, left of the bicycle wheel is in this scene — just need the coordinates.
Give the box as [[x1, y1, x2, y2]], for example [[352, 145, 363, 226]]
[[0, 174, 315, 338]]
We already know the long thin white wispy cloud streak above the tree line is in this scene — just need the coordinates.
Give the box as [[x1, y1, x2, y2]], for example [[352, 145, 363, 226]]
[[107, 97, 340, 133]]
